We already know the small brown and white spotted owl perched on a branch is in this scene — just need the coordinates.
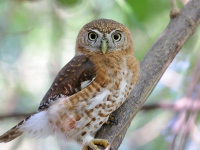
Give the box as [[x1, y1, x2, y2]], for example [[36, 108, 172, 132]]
[[0, 19, 139, 150]]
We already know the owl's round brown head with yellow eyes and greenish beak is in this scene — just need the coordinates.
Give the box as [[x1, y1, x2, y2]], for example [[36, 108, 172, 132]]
[[76, 19, 133, 54]]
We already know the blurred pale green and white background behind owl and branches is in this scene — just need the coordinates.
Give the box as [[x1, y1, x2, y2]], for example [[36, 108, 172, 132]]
[[0, 0, 200, 150]]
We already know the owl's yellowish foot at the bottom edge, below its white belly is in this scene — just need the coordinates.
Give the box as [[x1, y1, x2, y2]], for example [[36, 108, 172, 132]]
[[82, 139, 109, 150]]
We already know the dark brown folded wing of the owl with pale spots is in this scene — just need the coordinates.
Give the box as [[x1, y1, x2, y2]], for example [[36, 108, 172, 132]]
[[39, 55, 96, 110]]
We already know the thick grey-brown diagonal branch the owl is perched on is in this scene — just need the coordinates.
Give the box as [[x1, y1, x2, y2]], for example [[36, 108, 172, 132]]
[[96, 0, 200, 150]]
